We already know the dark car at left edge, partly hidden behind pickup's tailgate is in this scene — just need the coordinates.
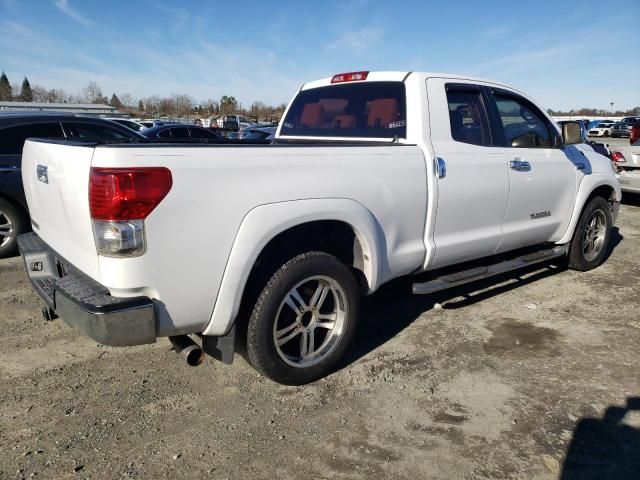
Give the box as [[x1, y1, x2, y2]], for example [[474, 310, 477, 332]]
[[0, 113, 144, 258]]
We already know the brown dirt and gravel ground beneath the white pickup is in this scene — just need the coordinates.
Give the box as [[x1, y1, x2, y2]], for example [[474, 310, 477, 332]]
[[0, 193, 640, 480]]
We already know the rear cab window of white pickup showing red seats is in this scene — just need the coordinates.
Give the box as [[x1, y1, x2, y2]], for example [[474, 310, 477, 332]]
[[280, 82, 407, 138]]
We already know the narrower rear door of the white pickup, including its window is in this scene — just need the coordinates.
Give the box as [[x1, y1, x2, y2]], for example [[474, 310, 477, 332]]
[[427, 78, 509, 268]]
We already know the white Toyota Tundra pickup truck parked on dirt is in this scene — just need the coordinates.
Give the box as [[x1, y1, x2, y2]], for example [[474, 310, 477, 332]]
[[19, 72, 621, 384]]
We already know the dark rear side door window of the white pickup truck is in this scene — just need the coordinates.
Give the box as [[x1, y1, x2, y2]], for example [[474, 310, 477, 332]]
[[447, 86, 491, 146]]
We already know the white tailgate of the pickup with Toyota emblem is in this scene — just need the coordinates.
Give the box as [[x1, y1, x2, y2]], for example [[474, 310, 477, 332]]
[[22, 140, 99, 280]]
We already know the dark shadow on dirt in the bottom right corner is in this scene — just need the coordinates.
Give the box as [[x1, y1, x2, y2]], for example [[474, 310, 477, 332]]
[[560, 397, 640, 480]]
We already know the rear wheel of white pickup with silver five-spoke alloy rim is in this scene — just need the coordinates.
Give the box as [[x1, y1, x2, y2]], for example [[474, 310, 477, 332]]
[[247, 252, 360, 385]]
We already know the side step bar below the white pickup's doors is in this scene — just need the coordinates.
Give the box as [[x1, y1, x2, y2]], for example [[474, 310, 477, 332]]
[[413, 245, 568, 295]]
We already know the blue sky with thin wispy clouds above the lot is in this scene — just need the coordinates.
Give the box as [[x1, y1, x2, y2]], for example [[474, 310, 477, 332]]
[[0, 0, 640, 109]]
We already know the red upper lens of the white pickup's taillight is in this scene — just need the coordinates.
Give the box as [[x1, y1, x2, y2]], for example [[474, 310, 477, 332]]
[[89, 167, 173, 221]]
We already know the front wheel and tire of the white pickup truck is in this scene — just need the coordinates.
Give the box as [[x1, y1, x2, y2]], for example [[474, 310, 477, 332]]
[[568, 197, 613, 272]]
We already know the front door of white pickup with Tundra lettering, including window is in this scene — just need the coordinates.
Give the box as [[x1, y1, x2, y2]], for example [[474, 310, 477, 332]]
[[489, 89, 586, 251]]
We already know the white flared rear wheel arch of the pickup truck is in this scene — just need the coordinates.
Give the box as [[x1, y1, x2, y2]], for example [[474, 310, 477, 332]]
[[203, 199, 389, 335]]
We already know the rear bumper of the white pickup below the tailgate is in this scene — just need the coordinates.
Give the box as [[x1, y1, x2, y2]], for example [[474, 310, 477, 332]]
[[18, 233, 156, 346]]
